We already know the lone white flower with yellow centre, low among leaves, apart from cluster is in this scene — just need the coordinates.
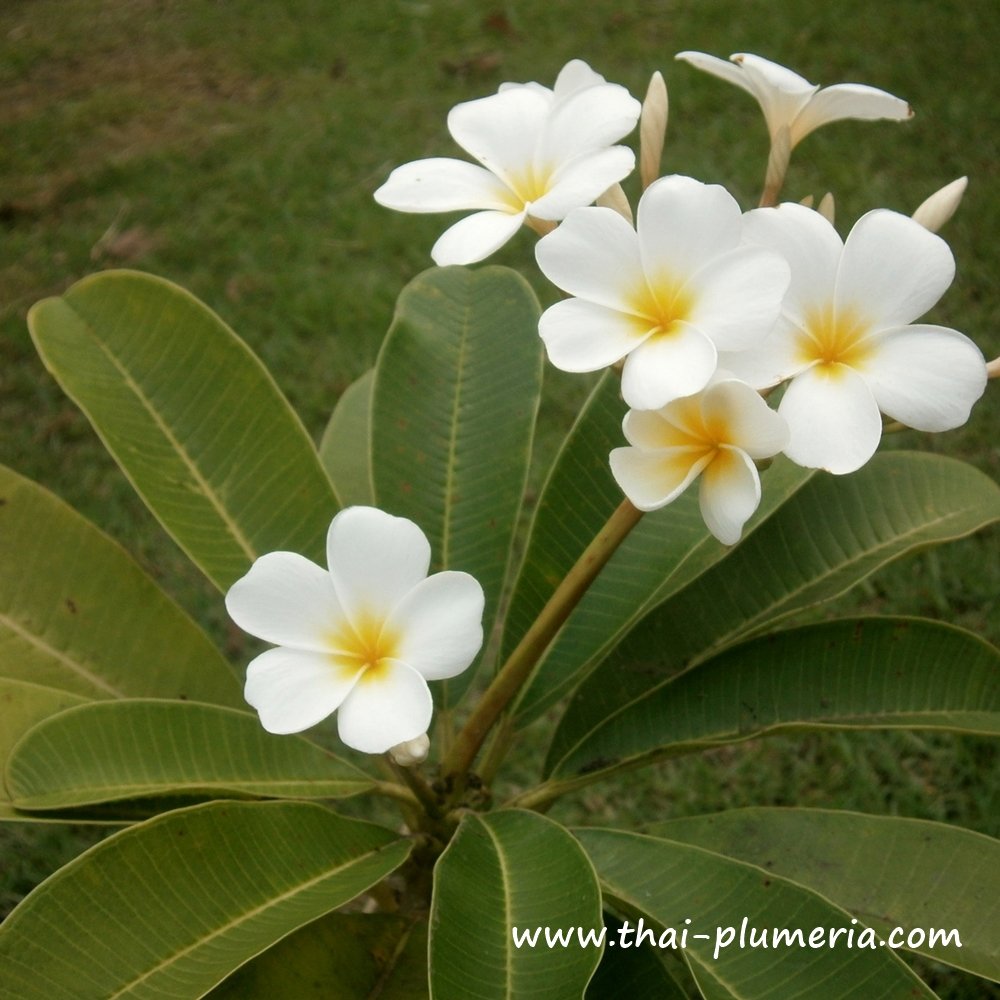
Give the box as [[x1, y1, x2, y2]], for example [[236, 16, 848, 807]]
[[226, 507, 483, 753]]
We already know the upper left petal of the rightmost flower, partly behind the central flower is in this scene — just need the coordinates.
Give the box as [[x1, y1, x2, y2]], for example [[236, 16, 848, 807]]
[[743, 203, 844, 320]]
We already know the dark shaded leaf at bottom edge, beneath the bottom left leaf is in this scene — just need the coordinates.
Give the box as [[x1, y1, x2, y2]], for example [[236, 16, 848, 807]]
[[208, 913, 428, 1000]]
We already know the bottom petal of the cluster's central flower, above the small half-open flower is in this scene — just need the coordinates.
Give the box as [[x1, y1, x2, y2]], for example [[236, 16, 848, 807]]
[[622, 323, 717, 410]]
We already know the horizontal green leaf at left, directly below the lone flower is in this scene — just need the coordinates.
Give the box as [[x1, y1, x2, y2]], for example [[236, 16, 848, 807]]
[[6, 701, 372, 809]]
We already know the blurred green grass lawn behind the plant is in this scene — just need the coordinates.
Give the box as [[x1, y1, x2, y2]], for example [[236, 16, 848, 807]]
[[0, 0, 1000, 997]]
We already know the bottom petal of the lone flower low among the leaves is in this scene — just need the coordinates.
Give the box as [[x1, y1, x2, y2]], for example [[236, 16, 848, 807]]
[[337, 660, 434, 753]]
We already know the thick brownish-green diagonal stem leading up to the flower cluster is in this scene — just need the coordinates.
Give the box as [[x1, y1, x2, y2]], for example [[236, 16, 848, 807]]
[[442, 500, 642, 775]]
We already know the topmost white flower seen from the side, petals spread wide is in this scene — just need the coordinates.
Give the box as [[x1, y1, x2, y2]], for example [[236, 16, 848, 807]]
[[677, 52, 913, 148]]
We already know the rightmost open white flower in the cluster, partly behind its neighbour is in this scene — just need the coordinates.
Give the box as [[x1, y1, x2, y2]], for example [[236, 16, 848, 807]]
[[722, 204, 986, 474]]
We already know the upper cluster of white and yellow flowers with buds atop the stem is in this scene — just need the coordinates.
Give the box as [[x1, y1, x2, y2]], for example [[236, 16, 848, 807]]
[[376, 52, 986, 544]]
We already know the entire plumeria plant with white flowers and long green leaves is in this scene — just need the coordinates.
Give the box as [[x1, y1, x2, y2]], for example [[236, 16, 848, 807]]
[[0, 52, 1000, 1000]]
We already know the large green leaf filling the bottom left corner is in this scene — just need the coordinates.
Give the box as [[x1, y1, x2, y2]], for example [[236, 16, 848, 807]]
[[0, 802, 410, 1000]]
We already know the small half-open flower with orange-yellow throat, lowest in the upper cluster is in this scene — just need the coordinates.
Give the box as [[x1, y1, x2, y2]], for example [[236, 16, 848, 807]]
[[611, 373, 788, 545]]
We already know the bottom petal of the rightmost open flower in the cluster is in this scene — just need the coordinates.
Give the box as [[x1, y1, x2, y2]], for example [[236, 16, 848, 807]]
[[778, 365, 882, 475]]
